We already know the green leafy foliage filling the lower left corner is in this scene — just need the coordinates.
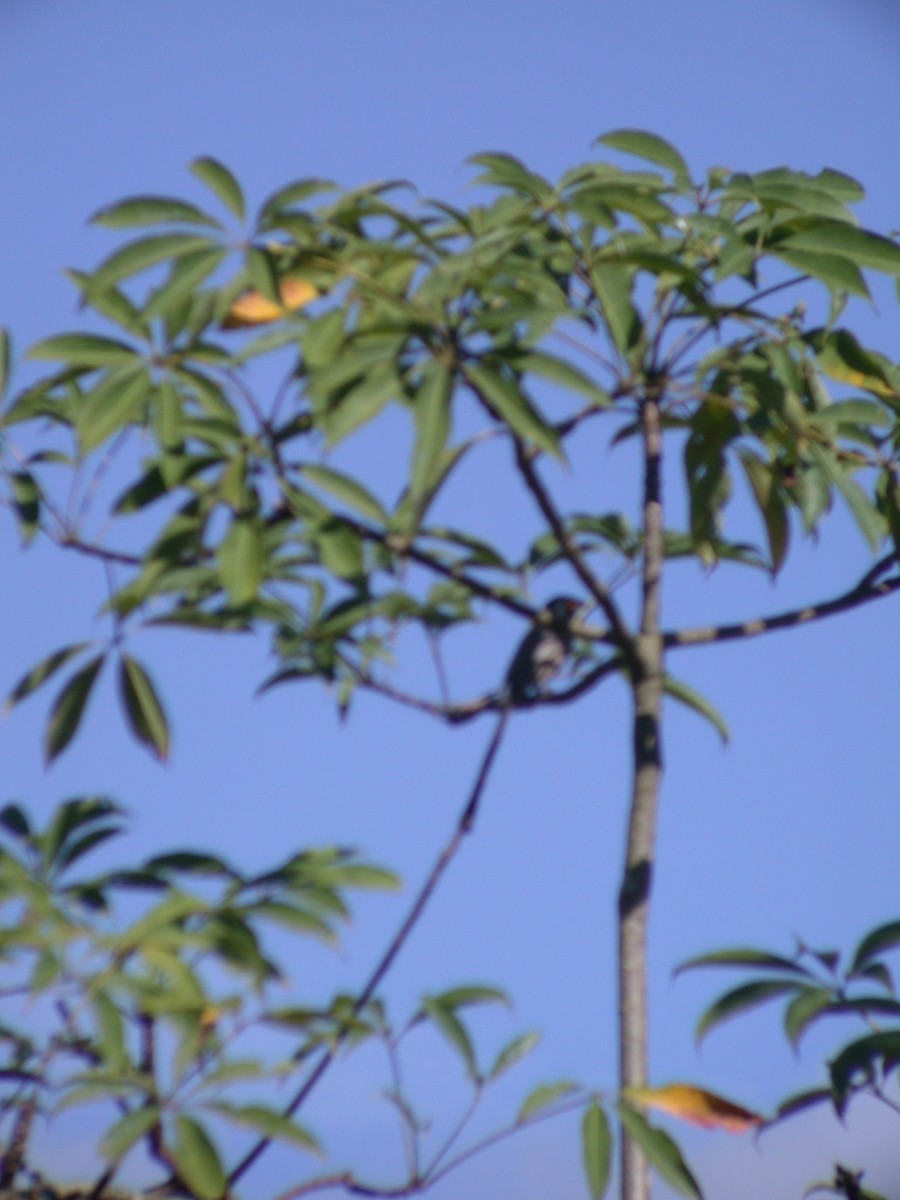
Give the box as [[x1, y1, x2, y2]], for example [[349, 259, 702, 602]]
[[0, 797, 586, 1200]]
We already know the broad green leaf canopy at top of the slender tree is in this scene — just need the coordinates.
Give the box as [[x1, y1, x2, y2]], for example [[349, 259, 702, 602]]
[[2, 131, 900, 757]]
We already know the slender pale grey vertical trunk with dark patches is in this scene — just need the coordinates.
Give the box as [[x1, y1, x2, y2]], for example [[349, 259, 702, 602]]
[[619, 394, 662, 1200]]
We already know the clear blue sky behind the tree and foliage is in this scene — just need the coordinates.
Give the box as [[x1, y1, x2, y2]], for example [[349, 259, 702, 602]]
[[0, 0, 900, 1200]]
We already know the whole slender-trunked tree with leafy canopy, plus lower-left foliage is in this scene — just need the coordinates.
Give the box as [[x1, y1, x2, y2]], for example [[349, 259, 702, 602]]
[[4, 131, 900, 1200]]
